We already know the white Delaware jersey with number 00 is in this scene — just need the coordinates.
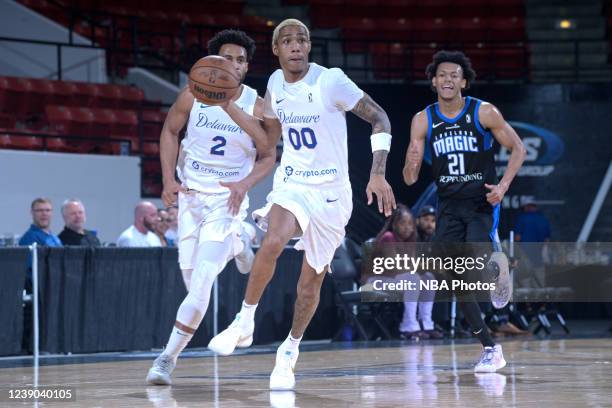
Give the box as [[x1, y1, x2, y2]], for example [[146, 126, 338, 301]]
[[266, 63, 363, 187]]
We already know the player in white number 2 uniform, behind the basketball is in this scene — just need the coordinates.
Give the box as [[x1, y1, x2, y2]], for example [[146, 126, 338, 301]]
[[147, 30, 276, 385]]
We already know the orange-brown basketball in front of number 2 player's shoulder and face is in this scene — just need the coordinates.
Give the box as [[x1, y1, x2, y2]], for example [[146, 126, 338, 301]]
[[189, 55, 240, 105]]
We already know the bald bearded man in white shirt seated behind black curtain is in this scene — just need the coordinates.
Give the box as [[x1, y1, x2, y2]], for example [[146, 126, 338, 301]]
[[117, 201, 162, 247]]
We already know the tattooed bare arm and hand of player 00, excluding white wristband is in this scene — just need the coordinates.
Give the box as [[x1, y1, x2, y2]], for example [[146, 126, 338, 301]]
[[351, 92, 395, 217]]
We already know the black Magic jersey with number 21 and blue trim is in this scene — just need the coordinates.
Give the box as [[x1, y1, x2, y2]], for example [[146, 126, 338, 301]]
[[426, 96, 497, 198]]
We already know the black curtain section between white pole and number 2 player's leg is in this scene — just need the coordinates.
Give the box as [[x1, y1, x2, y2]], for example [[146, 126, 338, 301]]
[[41, 248, 186, 353]]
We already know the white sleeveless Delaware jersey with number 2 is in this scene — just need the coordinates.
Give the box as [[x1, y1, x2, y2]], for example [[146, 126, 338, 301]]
[[177, 85, 257, 193]]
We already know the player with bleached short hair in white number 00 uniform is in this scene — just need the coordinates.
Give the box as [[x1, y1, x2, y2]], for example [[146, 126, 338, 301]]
[[208, 19, 395, 390]]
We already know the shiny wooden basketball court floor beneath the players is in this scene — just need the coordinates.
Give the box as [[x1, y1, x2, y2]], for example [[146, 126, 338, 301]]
[[0, 328, 612, 408]]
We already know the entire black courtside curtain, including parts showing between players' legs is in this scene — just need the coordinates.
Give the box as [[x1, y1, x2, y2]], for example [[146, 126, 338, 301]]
[[32, 247, 337, 353]]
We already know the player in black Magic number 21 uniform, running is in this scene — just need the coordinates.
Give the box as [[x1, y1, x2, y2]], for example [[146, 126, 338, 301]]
[[403, 51, 525, 372]]
